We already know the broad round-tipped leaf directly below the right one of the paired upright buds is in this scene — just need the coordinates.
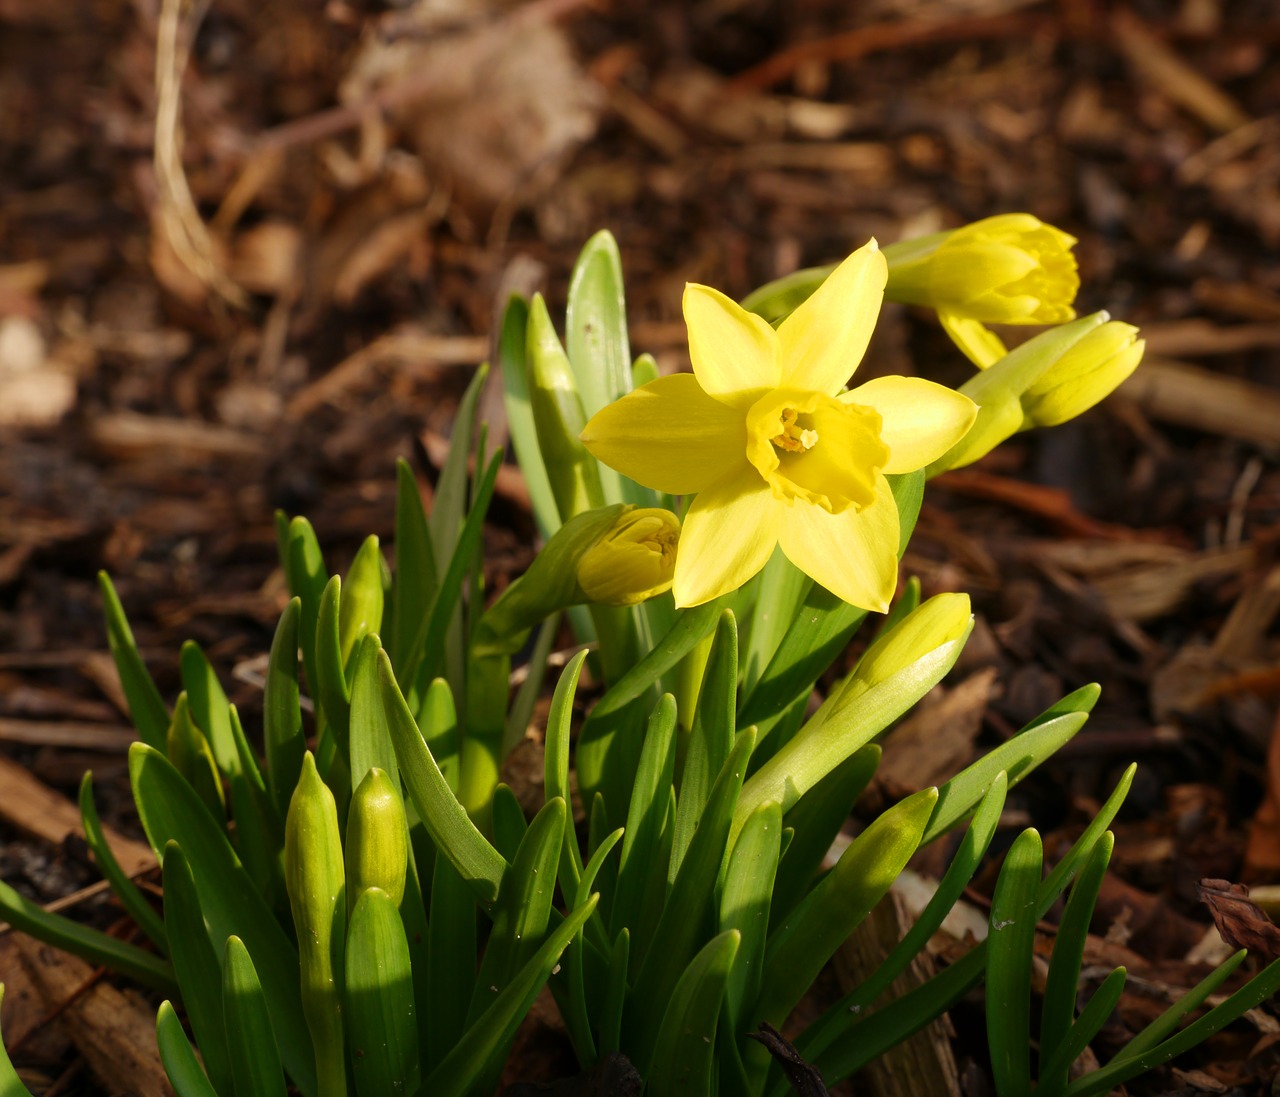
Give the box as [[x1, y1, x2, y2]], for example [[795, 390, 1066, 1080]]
[[346, 887, 420, 1097]]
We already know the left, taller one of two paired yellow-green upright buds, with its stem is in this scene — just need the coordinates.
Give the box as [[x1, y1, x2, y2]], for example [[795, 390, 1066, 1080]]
[[284, 751, 347, 1097]]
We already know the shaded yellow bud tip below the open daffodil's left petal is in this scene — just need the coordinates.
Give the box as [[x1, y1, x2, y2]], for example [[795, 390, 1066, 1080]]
[[577, 507, 680, 605]]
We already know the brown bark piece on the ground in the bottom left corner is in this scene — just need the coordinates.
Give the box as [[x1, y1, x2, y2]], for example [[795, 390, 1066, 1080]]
[[15, 934, 173, 1097]]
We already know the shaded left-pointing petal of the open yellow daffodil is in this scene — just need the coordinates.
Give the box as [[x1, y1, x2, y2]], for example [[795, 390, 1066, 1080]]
[[579, 374, 750, 495]]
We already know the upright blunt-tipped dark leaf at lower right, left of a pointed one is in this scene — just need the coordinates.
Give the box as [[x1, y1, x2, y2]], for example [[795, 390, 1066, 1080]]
[[987, 829, 1043, 1097]]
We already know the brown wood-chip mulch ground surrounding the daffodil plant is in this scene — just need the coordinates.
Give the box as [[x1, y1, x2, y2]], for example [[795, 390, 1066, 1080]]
[[0, 0, 1280, 1094]]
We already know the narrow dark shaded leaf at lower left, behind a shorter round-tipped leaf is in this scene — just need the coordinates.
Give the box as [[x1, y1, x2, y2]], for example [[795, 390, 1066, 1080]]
[[164, 842, 234, 1093]]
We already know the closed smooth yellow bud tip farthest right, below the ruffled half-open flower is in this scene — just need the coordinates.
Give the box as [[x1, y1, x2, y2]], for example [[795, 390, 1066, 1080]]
[[1023, 320, 1147, 429]]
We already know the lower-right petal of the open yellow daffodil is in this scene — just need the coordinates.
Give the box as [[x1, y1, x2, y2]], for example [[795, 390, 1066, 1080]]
[[768, 476, 899, 613]]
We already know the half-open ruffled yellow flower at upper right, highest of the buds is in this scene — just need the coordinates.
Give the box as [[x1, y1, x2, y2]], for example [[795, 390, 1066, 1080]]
[[884, 214, 1080, 324]]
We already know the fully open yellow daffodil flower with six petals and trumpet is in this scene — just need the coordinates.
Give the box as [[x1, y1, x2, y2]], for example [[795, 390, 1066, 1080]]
[[581, 241, 977, 611]]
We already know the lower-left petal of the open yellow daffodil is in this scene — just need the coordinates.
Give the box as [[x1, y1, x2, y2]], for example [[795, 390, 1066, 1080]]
[[672, 467, 778, 605]]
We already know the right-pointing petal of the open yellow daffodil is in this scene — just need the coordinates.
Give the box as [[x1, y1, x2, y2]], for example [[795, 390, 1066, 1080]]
[[840, 376, 978, 472]]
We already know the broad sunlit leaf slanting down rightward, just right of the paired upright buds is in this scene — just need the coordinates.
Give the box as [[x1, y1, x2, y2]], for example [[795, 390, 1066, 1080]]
[[378, 652, 507, 909]]
